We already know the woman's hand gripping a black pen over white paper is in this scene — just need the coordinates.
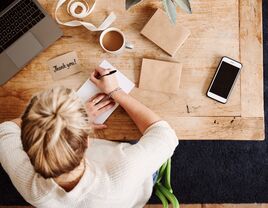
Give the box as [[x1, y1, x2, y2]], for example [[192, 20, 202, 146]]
[[90, 67, 119, 94]]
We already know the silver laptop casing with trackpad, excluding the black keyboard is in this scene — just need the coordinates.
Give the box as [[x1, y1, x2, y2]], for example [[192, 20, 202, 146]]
[[0, 0, 63, 85]]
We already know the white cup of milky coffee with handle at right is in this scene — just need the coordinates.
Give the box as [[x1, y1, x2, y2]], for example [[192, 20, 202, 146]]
[[99, 27, 134, 55]]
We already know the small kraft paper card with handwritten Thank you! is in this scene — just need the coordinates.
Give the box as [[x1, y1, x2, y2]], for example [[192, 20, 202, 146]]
[[48, 51, 81, 80]]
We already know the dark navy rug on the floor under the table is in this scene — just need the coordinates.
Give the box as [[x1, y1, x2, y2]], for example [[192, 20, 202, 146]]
[[0, 1, 268, 205]]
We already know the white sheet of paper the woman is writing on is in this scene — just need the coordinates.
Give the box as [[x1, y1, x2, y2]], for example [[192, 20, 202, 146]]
[[77, 60, 135, 124]]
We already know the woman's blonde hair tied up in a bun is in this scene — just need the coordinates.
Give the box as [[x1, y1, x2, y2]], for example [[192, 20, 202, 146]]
[[21, 87, 90, 178]]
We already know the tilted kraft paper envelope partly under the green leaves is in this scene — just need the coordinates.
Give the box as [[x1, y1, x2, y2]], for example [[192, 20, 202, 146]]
[[141, 9, 191, 56]]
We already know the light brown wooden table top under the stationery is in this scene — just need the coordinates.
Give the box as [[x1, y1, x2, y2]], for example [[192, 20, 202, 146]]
[[0, 0, 264, 140]]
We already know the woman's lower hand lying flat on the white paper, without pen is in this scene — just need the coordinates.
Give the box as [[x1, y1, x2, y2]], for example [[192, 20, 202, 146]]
[[86, 94, 115, 129]]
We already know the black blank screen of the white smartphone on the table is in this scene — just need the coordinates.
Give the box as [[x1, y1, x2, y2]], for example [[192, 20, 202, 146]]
[[209, 61, 240, 99]]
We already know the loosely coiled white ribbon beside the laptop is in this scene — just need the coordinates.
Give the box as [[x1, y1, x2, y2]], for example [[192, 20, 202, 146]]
[[55, 0, 116, 31]]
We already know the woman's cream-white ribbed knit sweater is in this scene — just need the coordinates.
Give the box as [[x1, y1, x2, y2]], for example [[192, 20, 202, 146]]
[[0, 121, 178, 208]]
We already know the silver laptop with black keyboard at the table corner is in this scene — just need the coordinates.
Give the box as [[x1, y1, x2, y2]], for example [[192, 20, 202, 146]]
[[0, 0, 63, 85]]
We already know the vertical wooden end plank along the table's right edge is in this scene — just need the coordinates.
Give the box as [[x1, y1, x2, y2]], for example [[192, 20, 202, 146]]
[[240, 0, 264, 117]]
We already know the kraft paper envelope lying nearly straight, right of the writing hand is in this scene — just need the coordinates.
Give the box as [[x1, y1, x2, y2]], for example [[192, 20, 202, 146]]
[[139, 59, 182, 94]]
